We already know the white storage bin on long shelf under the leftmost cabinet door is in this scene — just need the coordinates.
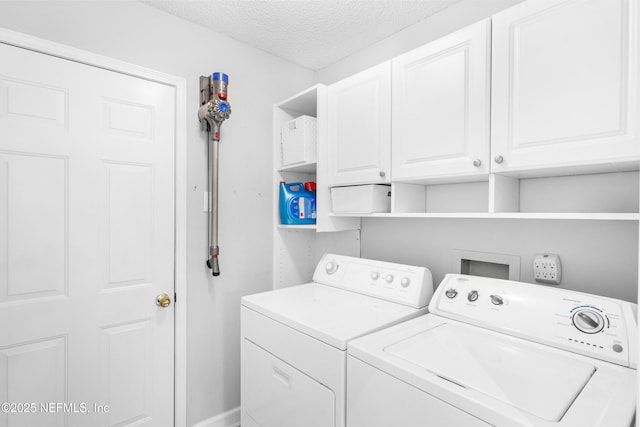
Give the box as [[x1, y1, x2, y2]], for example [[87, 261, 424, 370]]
[[331, 184, 391, 214]]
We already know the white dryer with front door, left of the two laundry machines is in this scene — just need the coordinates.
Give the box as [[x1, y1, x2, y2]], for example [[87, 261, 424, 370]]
[[241, 254, 433, 427]]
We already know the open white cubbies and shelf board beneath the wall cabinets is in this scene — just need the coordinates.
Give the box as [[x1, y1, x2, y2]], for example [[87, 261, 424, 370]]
[[333, 170, 640, 221]]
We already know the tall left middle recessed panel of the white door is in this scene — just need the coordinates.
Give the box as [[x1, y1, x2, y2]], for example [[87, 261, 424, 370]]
[[0, 154, 67, 301]]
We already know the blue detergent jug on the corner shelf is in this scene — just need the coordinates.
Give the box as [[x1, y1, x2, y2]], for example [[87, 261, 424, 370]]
[[280, 181, 316, 224]]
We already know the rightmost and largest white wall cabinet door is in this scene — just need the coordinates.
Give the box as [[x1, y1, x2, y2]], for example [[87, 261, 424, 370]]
[[491, 0, 640, 172]]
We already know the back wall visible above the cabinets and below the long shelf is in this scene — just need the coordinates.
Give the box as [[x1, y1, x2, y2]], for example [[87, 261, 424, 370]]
[[318, 0, 638, 302]]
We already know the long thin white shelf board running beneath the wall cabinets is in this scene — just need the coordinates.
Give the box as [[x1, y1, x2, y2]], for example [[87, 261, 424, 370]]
[[330, 212, 640, 221]]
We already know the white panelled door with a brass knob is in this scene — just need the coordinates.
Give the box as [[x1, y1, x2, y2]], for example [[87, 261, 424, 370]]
[[0, 44, 175, 427]]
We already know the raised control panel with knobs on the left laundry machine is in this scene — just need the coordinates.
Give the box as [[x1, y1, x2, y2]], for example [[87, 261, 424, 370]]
[[313, 254, 433, 308]]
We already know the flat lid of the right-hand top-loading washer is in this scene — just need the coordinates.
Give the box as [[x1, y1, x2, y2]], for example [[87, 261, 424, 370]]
[[384, 323, 596, 422]]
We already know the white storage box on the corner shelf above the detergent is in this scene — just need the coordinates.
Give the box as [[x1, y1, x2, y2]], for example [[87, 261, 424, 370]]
[[280, 116, 317, 167]]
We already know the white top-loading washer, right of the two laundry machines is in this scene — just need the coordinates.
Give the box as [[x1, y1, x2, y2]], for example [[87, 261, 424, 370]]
[[347, 274, 638, 427]]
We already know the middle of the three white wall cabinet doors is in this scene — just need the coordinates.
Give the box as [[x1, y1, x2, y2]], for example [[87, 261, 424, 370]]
[[391, 20, 491, 181]]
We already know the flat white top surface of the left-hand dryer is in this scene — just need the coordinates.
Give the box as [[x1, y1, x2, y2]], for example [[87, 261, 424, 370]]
[[242, 283, 427, 350]]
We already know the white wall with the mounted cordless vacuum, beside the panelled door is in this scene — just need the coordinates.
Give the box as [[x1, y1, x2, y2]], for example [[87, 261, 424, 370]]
[[0, 1, 316, 425]]
